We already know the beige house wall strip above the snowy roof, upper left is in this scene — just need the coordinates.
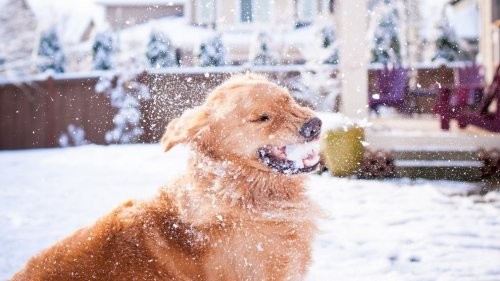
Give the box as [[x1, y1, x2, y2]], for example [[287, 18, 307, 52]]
[[106, 4, 184, 29]]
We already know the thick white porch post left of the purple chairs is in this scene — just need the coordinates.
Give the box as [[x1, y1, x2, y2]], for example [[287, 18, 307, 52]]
[[335, 0, 369, 119]]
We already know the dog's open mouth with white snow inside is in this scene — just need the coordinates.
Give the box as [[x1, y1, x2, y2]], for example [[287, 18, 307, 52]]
[[258, 137, 320, 174]]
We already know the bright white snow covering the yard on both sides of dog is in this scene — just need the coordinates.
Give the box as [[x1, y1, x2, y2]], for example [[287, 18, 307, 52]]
[[0, 145, 500, 281]]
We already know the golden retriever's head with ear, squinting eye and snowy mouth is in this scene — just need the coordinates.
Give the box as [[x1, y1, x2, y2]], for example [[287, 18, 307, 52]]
[[161, 74, 321, 174]]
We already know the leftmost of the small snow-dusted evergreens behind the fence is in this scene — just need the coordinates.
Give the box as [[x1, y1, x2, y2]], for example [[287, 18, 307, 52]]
[[38, 28, 66, 73]]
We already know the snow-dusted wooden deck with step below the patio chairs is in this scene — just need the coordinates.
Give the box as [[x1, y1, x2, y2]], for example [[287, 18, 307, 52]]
[[365, 115, 500, 180]]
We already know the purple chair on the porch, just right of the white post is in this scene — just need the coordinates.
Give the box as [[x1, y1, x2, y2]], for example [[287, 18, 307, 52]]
[[368, 67, 408, 112]]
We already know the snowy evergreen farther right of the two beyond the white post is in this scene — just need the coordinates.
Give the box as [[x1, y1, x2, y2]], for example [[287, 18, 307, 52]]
[[432, 13, 463, 61]]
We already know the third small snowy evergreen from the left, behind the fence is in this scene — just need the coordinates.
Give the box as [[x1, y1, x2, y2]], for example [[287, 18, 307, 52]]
[[146, 31, 179, 68]]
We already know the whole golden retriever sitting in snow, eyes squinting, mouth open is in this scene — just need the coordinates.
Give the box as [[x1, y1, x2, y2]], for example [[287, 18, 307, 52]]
[[12, 74, 321, 281]]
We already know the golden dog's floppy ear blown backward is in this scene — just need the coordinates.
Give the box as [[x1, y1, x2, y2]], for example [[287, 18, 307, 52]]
[[160, 106, 208, 152]]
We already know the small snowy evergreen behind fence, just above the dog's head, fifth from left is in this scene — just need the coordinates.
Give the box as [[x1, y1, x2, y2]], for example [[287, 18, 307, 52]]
[[250, 32, 279, 65]]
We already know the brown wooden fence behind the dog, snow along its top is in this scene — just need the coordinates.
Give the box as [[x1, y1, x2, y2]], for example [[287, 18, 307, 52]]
[[0, 65, 453, 149]]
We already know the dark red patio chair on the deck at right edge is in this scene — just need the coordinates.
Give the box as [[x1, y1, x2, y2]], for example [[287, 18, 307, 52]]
[[434, 65, 500, 132]]
